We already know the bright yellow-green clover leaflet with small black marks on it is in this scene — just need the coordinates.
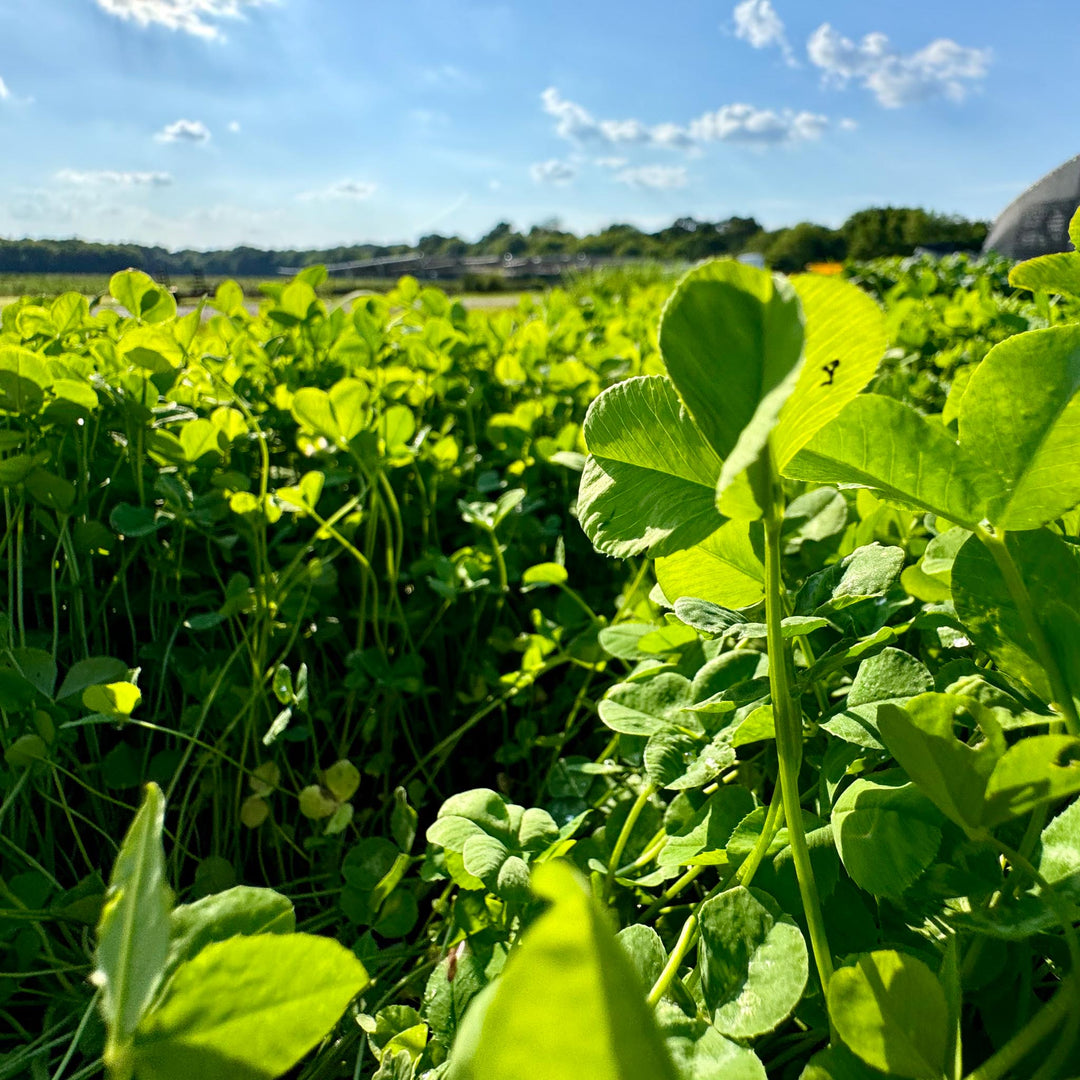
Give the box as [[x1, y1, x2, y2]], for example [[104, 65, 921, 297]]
[[772, 274, 888, 468]]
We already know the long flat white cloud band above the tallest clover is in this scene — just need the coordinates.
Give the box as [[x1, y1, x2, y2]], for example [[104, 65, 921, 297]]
[[540, 86, 828, 153]]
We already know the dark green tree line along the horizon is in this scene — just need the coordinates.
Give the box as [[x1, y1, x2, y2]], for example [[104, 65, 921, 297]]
[[0, 206, 988, 278]]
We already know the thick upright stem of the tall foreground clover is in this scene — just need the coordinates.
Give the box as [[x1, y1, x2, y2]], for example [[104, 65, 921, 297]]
[[765, 499, 833, 989]]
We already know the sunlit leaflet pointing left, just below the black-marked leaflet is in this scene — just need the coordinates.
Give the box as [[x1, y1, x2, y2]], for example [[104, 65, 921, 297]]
[[782, 394, 999, 527]]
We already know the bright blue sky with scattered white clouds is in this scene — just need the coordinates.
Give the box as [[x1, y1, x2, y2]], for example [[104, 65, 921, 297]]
[[0, 0, 1080, 247]]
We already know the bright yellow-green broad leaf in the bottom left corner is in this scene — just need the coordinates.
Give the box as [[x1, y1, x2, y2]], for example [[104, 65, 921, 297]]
[[131, 934, 368, 1080]]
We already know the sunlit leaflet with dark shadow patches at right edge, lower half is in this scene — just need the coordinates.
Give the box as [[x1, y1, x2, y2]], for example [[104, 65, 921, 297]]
[[983, 734, 1080, 827]]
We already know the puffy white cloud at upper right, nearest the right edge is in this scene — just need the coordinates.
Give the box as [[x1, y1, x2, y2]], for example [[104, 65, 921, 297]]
[[807, 23, 990, 109]]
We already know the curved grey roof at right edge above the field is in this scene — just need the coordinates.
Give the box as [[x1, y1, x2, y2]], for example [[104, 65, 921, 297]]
[[983, 154, 1080, 259]]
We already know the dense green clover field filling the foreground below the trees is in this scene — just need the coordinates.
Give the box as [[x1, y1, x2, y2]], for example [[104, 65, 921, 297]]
[[0, 255, 1080, 1080]]
